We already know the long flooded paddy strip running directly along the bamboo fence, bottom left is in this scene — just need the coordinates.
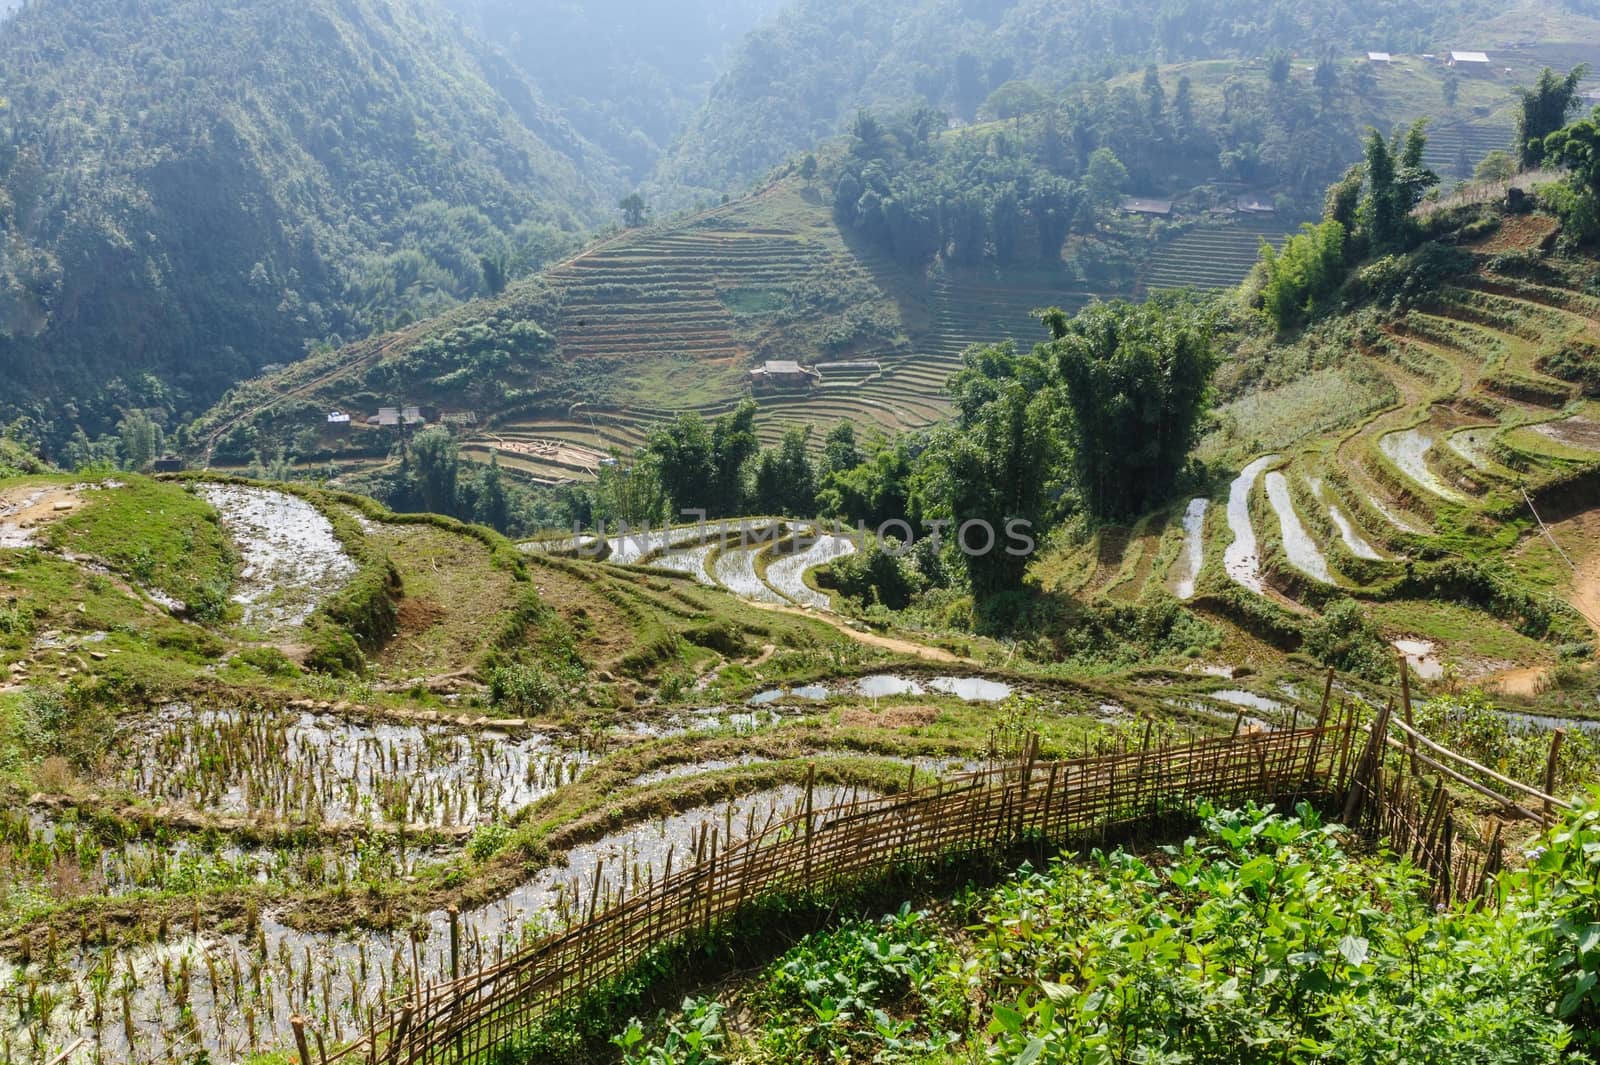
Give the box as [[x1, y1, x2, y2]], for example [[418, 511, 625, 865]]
[[0, 787, 870, 1065]]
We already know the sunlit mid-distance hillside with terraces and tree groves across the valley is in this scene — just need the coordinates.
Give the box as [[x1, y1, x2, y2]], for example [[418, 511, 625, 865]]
[[190, 45, 1561, 485]]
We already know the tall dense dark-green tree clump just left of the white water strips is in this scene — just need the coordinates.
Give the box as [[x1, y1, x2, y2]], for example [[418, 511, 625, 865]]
[[1032, 299, 1216, 521]]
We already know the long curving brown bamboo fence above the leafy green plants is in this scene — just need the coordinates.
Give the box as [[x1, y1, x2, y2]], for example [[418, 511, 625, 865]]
[[328, 713, 1355, 1065]]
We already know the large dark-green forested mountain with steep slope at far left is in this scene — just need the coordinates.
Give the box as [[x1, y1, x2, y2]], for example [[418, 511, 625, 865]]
[[0, 0, 614, 435]]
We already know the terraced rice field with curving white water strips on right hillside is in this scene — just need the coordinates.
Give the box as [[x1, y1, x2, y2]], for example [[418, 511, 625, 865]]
[[1072, 216, 1600, 652]]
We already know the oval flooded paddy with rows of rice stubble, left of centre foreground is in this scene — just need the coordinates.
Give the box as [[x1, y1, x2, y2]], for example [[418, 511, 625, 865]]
[[114, 705, 589, 827]]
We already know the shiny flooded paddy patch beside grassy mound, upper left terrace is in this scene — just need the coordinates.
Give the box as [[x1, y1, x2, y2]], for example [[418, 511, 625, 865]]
[[200, 485, 355, 633]]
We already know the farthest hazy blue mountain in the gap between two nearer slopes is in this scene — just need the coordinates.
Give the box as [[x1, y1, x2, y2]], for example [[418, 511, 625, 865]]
[[448, 0, 781, 179]]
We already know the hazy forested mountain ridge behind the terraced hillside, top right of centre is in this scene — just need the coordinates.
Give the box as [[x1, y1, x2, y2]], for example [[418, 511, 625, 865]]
[[661, 0, 1490, 190]]
